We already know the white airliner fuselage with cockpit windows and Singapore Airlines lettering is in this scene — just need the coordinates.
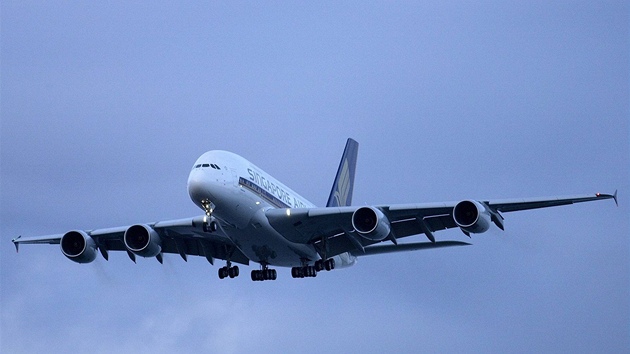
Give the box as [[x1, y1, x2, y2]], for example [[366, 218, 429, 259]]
[[188, 150, 355, 267]]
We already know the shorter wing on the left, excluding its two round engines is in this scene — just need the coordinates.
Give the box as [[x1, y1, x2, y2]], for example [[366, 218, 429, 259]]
[[13, 217, 249, 264]]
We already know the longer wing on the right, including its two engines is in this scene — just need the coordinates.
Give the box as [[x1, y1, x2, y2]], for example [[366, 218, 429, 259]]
[[266, 191, 617, 257]]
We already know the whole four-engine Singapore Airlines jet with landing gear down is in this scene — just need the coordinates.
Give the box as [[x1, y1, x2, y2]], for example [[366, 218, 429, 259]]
[[13, 139, 617, 281]]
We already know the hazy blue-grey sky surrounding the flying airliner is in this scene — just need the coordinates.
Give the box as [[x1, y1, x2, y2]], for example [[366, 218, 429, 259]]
[[0, 0, 630, 353]]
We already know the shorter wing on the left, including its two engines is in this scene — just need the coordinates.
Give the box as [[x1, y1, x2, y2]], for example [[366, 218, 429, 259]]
[[13, 217, 249, 264]]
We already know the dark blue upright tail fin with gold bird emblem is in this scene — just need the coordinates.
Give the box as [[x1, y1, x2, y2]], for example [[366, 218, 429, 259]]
[[326, 139, 359, 207]]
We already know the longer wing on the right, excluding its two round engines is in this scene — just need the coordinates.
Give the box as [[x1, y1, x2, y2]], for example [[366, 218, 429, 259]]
[[266, 191, 617, 257]]
